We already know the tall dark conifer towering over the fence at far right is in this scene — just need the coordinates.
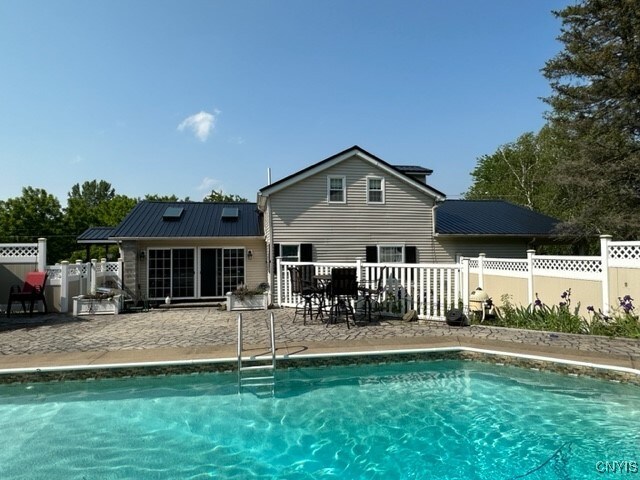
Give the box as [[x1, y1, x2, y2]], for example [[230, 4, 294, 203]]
[[543, 0, 640, 239]]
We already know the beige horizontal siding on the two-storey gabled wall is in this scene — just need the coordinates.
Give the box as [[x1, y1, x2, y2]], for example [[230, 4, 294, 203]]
[[270, 157, 434, 262]]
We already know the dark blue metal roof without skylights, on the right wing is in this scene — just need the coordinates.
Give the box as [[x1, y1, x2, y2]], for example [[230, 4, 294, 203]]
[[435, 200, 560, 236]]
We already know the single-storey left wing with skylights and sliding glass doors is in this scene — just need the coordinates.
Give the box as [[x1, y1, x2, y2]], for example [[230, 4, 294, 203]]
[[109, 201, 266, 300]]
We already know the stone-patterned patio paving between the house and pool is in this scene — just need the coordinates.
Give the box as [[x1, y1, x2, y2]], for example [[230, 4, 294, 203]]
[[0, 307, 640, 370]]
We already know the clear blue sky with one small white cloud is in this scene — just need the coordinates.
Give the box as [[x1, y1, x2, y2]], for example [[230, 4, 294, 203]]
[[0, 0, 573, 207]]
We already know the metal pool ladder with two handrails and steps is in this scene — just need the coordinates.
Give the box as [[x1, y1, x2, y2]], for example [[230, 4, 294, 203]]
[[238, 313, 276, 395]]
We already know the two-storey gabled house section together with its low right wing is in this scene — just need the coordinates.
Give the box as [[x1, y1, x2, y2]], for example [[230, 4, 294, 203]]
[[258, 146, 556, 282]]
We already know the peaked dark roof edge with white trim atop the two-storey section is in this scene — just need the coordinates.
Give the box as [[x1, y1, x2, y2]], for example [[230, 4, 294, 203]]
[[258, 145, 445, 201]]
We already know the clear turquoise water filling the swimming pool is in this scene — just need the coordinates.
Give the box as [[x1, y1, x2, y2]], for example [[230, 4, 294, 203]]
[[0, 361, 640, 480]]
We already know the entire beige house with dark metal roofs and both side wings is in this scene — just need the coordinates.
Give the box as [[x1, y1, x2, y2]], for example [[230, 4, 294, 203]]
[[79, 146, 557, 300]]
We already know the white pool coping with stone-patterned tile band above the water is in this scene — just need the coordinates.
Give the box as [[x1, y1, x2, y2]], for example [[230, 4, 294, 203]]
[[0, 344, 640, 386]]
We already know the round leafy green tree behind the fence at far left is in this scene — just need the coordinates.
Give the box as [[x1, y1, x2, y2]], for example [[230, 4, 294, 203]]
[[0, 187, 68, 263]]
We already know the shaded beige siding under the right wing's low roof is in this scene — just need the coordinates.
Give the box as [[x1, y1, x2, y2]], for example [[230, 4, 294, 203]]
[[435, 236, 528, 263]]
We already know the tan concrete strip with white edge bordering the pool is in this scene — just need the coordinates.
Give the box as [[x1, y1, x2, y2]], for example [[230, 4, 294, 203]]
[[0, 336, 640, 377]]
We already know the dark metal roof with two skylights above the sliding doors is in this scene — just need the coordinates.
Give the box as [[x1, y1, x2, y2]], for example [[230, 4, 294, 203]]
[[111, 201, 263, 240]]
